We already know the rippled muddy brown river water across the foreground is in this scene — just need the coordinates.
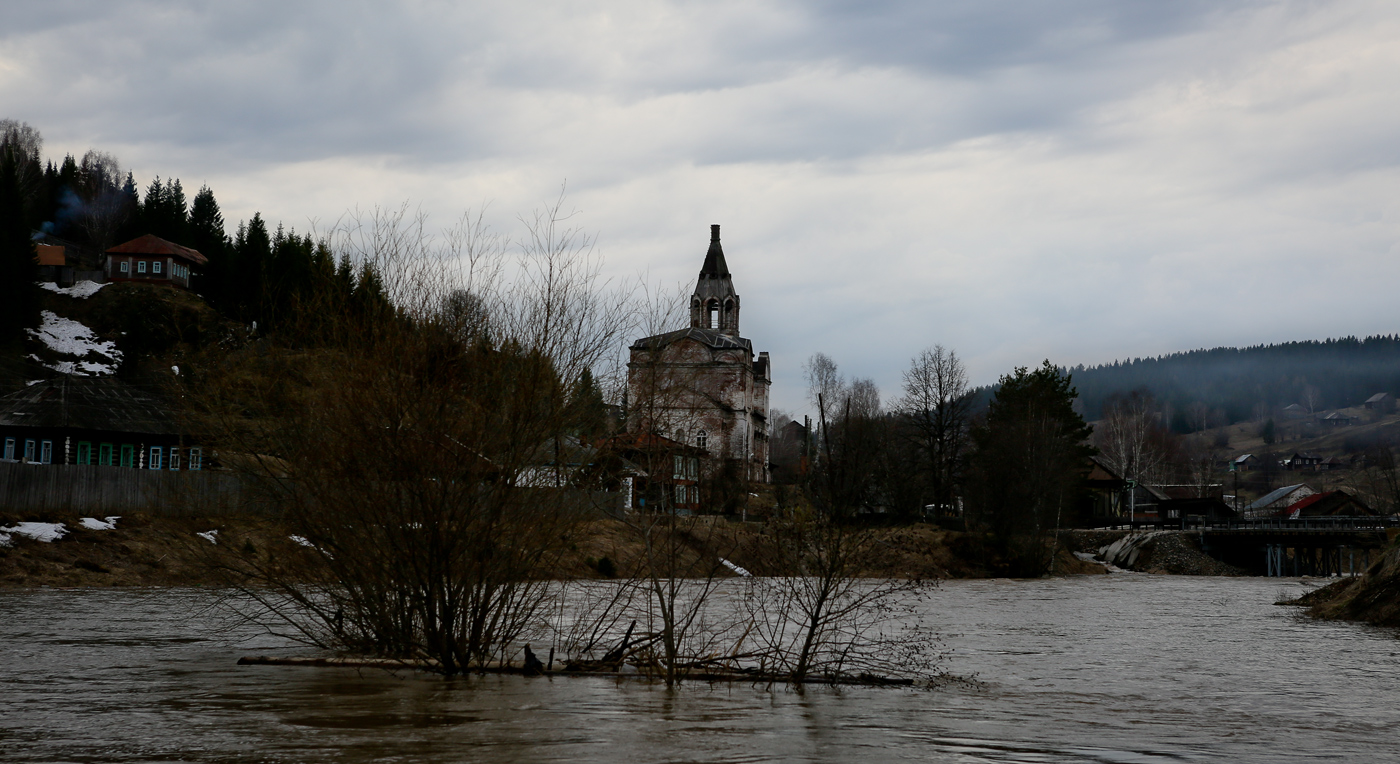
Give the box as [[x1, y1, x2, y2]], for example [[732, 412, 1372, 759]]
[[0, 574, 1400, 763]]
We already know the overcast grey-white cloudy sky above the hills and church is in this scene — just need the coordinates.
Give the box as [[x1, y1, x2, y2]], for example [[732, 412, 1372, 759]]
[[0, 0, 1400, 413]]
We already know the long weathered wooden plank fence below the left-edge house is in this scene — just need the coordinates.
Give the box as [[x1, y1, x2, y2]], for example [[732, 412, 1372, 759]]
[[0, 462, 265, 515]]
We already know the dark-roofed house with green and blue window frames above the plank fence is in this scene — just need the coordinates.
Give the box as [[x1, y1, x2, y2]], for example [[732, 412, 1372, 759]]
[[0, 376, 209, 470]]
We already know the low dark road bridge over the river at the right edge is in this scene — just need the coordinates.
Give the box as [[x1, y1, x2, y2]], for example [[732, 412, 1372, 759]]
[[1131, 516, 1400, 576]]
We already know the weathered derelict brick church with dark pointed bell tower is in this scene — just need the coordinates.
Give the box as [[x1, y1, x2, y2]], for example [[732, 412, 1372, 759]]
[[627, 225, 773, 483]]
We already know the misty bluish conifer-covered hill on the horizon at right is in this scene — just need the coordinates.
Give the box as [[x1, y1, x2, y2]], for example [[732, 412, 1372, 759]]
[[1065, 334, 1400, 431]]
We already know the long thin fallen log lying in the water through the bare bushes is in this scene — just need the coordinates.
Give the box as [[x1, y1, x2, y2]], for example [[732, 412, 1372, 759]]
[[238, 655, 914, 687]]
